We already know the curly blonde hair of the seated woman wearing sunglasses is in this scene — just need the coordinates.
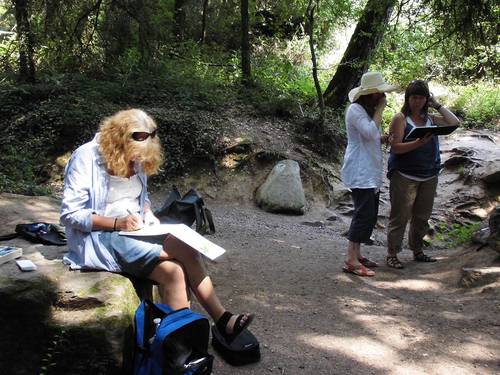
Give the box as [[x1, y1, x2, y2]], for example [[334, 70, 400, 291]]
[[99, 109, 163, 177]]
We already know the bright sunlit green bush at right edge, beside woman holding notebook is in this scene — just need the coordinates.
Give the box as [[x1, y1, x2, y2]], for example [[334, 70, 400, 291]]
[[452, 83, 500, 130]]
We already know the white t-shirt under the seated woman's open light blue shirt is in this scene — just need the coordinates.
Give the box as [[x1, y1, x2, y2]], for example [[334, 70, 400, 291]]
[[104, 174, 142, 217]]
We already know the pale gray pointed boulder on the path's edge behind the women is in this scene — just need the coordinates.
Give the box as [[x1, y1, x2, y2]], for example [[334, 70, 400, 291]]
[[255, 160, 306, 215]]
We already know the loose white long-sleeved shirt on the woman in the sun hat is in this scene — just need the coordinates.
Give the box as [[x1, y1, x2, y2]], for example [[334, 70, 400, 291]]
[[341, 103, 383, 189]]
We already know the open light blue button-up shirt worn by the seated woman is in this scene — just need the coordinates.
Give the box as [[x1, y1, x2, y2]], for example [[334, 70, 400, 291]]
[[60, 134, 149, 272]]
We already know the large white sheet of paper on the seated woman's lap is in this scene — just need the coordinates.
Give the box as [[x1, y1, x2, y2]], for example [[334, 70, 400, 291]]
[[118, 224, 226, 260]]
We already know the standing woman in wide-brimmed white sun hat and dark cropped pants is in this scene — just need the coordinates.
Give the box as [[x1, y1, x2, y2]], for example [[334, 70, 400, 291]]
[[342, 72, 396, 276]]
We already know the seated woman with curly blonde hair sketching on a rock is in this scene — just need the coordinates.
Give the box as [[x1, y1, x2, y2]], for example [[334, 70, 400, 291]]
[[61, 109, 253, 341]]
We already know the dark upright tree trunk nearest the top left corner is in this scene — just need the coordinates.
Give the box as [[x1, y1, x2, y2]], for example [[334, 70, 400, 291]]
[[13, 0, 35, 82]]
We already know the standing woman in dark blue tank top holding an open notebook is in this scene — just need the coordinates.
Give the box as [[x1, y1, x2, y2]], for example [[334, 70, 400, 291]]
[[386, 80, 459, 269]]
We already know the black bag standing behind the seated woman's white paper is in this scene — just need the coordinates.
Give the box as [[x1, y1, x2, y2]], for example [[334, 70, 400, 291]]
[[154, 186, 215, 234]]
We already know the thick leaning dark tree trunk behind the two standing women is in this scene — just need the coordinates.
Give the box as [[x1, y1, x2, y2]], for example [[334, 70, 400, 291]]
[[323, 0, 396, 108]]
